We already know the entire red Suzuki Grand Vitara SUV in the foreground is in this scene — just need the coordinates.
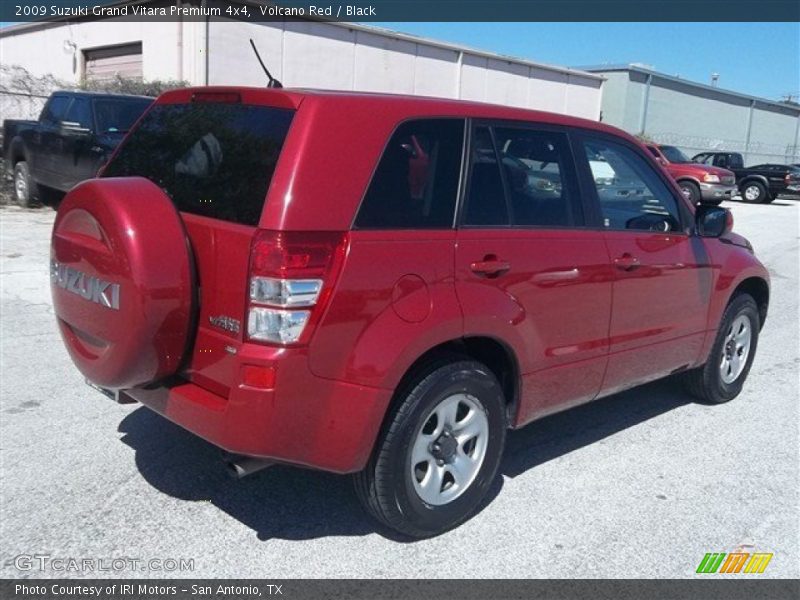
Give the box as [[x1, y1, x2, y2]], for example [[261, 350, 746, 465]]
[[51, 88, 769, 537]]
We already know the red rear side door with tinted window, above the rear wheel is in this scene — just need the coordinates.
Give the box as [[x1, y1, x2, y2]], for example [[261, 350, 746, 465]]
[[456, 123, 611, 425]]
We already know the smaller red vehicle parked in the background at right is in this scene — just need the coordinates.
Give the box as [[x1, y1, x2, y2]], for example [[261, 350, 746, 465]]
[[647, 144, 738, 204]]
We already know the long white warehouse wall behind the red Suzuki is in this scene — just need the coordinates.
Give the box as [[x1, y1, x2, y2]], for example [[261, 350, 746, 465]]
[[0, 19, 602, 119]]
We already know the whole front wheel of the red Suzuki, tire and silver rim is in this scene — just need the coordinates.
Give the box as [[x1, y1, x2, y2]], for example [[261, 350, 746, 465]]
[[684, 294, 760, 404]]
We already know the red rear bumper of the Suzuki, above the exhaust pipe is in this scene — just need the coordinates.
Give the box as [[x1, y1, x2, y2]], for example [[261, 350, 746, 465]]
[[122, 346, 391, 473]]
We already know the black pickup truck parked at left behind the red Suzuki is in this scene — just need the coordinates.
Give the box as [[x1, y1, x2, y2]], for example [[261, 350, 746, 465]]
[[3, 92, 153, 206]]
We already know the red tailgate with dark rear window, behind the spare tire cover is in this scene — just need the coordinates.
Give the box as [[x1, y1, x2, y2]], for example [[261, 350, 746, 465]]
[[103, 93, 294, 396]]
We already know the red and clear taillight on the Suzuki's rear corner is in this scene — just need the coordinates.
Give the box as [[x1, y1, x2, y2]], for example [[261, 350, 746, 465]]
[[247, 231, 347, 345]]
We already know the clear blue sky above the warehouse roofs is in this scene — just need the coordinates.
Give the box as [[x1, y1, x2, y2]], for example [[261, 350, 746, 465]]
[[369, 23, 800, 101]]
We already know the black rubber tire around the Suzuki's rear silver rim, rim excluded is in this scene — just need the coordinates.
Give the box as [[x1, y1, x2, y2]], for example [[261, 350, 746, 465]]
[[355, 356, 506, 538]]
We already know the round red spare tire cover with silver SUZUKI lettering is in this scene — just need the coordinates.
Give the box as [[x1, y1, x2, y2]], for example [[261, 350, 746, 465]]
[[50, 177, 194, 389]]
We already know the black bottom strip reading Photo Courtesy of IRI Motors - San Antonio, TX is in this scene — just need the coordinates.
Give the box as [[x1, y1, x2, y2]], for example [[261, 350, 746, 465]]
[[0, 575, 800, 600]]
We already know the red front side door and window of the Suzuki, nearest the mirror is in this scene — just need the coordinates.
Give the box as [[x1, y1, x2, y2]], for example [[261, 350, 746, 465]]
[[580, 135, 711, 394]]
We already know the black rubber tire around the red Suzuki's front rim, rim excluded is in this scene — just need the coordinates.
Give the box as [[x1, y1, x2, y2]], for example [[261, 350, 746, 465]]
[[683, 294, 761, 404]]
